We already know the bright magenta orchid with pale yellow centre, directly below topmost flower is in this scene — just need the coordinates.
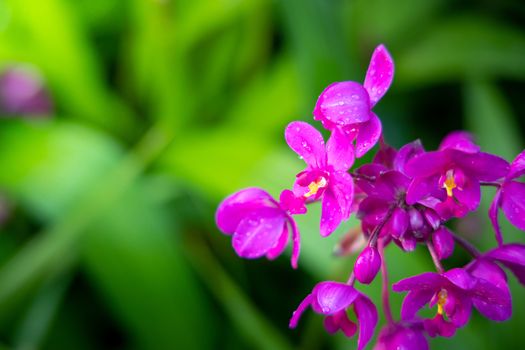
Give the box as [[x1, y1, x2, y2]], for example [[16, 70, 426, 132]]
[[285, 122, 354, 237]]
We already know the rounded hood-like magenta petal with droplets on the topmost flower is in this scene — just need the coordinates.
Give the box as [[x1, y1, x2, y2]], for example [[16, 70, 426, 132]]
[[314, 81, 370, 126]]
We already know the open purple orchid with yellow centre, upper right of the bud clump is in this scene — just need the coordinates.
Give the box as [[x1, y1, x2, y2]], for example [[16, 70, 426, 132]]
[[405, 132, 509, 219]]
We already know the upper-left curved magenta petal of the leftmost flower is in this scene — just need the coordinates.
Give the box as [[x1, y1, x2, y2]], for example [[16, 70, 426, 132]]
[[215, 188, 277, 234]]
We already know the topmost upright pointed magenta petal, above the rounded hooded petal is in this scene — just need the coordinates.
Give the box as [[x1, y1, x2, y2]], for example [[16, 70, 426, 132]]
[[363, 45, 394, 107]]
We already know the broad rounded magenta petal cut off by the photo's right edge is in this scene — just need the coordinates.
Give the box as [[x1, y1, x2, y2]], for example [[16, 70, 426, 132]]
[[501, 181, 525, 230]]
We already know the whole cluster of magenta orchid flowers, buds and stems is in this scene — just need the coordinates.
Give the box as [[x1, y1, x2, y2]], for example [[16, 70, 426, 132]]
[[216, 45, 525, 349]]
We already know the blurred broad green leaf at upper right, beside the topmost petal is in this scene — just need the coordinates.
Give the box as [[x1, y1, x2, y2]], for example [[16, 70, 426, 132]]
[[396, 17, 525, 85]]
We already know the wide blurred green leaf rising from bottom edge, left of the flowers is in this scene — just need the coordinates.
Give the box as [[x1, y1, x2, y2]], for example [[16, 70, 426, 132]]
[[82, 179, 213, 349]]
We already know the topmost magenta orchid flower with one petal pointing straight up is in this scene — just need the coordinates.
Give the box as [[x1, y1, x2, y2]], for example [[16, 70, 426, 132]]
[[313, 45, 394, 158]]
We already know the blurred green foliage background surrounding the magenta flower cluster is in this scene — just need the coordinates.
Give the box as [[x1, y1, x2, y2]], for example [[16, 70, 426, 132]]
[[0, 0, 525, 349]]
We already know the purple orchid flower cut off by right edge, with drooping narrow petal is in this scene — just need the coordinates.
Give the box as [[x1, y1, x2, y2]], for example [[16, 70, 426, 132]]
[[489, 150, 525, 245]]
